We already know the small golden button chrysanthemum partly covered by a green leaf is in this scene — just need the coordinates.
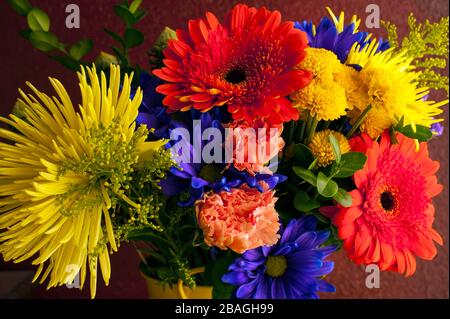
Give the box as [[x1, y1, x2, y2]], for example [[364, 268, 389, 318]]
[[308, 130, 350, 167]]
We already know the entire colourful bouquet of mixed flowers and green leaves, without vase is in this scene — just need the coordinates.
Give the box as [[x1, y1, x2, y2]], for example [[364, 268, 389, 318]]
[[0, 0, 449, 299]]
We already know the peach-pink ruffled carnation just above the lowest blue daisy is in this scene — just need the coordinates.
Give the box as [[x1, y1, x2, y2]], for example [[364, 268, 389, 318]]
[[195, 185, 280, 253]]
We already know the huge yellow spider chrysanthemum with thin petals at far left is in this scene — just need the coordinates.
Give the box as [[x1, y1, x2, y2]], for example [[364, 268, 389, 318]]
[[0, 66, 164, 297]]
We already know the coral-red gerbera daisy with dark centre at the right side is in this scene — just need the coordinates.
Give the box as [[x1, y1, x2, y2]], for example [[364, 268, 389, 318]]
[[333, 132, 443, 276]]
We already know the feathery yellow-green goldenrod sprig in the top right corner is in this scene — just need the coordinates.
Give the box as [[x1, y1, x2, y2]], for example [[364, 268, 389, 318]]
[[382, 13, 449, 96]]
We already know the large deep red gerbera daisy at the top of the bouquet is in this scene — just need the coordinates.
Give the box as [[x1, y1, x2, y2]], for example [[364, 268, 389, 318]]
[[154, 5, 311, 124]]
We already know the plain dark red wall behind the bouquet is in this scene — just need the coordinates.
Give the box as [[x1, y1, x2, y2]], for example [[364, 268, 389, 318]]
[[0, 0, 449, 298]]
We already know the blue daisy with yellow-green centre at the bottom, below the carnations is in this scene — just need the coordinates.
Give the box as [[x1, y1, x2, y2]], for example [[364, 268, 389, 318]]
[[222, 216, 337, 299]]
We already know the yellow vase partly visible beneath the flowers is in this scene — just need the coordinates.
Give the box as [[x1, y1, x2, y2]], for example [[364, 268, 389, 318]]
[[144, 268, 212, 299]]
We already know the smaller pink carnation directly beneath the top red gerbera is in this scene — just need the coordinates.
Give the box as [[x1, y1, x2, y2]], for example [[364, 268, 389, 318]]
[[226, 120, 284, 175]]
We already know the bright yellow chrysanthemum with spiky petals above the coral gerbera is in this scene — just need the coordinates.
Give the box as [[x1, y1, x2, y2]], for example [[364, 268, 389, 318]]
[[346, 41, 448, 138]]
